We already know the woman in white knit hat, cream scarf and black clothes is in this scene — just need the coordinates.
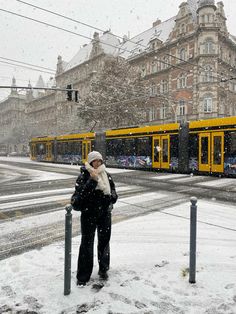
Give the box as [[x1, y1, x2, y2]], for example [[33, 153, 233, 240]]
[[75, 151, 118, 286]]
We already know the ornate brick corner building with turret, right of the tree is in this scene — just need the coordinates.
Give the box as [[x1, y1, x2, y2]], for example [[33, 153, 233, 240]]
[[121, 0, 236, 123]]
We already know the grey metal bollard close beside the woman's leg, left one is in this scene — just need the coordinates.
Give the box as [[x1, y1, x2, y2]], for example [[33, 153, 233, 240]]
[[64, 205, 72, 295]]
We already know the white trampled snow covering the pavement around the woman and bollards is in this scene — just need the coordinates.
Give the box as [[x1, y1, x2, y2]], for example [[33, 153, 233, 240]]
[[0, 200, 236, 314]]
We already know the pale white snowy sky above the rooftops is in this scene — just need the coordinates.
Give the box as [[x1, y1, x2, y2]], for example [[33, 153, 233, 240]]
[[0, 0, 236, 100]]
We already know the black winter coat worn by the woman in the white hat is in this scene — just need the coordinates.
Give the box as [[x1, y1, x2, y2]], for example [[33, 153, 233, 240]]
[[75, 166, 118, 212]]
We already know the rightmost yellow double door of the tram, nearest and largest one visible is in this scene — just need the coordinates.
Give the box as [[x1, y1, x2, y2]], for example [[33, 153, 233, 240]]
[[199, 132, 224, 172]]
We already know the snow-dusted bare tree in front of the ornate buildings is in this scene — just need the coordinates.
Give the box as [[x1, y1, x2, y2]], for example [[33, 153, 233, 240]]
[[79, 58, 148, 128]]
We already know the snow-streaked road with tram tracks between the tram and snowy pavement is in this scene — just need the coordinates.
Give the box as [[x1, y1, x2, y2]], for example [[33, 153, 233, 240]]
[[0, 158, 236, 259]]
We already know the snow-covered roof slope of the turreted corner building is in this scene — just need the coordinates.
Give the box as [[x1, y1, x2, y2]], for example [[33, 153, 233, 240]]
[[120, 16, 176, 59]]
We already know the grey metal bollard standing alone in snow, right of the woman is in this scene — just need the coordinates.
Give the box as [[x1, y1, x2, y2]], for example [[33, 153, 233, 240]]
[[189, 197, 197, 283]]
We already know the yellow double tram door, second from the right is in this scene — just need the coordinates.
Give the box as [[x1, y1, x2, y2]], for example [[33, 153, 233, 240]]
[[152, 135, 170, 169]]
